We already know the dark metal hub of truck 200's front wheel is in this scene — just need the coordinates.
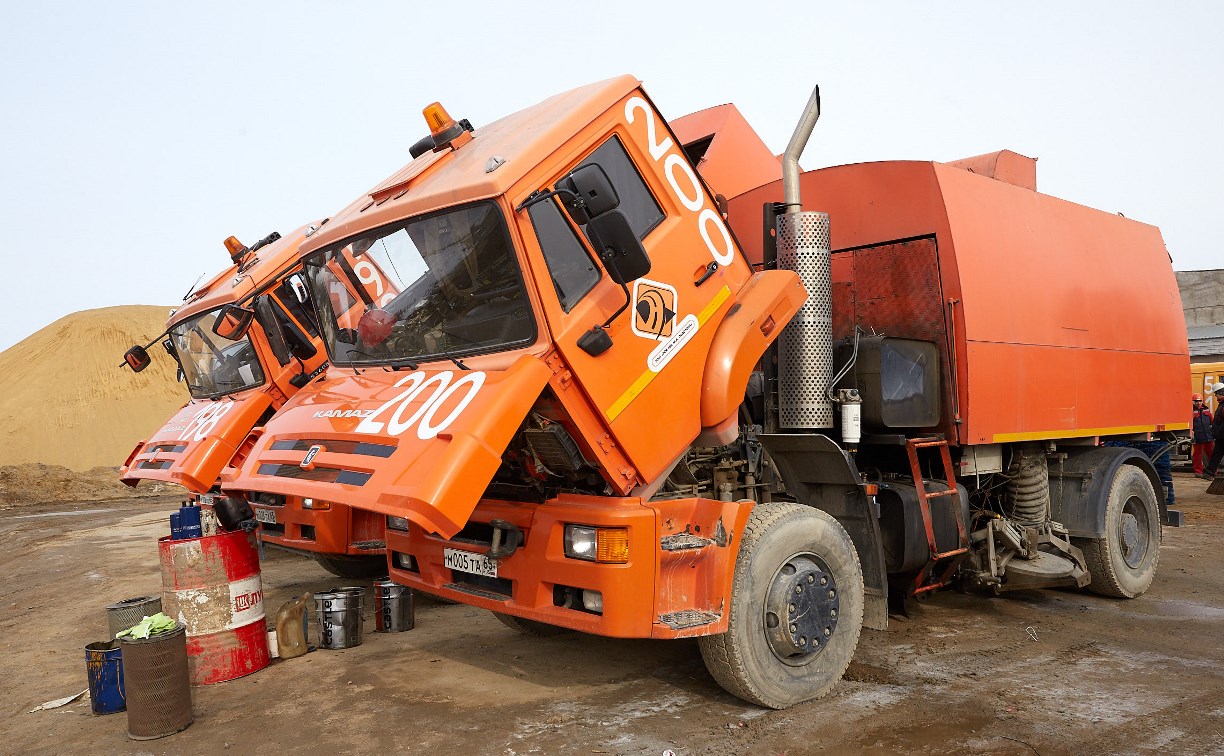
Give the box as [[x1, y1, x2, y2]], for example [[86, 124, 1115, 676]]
[[765, 554, 841, 664]]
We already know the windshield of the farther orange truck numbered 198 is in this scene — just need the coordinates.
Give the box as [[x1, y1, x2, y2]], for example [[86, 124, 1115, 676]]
[[170, 309, 263, 399]]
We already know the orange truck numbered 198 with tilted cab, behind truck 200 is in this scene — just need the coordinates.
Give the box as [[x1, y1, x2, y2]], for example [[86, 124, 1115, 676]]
[[120, 224, 386, 577]]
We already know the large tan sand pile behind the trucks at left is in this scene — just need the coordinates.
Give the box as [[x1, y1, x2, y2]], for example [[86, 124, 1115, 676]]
[[0, 305, 187, 469]]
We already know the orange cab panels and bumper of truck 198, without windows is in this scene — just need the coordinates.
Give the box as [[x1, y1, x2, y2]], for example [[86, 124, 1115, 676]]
[[120, 224, 382, 555]]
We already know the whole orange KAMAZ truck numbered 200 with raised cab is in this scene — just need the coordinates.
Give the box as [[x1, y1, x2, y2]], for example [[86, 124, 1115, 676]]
[[222, 76, 1189, 708]]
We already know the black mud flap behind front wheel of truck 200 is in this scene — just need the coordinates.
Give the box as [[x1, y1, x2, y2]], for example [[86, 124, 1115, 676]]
[[759, 433, 889, 630]]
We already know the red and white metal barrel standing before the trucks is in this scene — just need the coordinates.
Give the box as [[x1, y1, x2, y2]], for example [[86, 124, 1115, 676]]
[[158, 531, 268, 685]]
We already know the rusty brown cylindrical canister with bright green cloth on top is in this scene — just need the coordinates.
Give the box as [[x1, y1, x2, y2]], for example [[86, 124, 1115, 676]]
[[122, 625, 195, 740]]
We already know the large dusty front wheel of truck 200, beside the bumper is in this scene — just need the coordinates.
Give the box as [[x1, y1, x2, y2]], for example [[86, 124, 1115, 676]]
[[700, 503, 863, 708]]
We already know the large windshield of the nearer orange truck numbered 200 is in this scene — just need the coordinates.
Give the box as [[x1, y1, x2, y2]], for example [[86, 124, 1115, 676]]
[[306, 202, 536, 365]]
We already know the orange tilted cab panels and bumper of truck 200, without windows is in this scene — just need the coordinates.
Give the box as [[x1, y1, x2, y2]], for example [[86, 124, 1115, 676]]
[[222, 76, 805, 637]]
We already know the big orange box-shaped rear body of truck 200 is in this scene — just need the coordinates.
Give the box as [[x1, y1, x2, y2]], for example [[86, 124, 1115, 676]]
[[730, 150, 1190, 444]]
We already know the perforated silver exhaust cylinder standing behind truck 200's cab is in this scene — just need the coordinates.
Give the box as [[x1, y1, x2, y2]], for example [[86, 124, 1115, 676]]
[[777, 212, 834, 428]]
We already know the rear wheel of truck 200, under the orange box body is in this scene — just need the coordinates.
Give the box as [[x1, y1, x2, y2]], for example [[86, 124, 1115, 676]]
[[1075, 465, 1160, 598]]
